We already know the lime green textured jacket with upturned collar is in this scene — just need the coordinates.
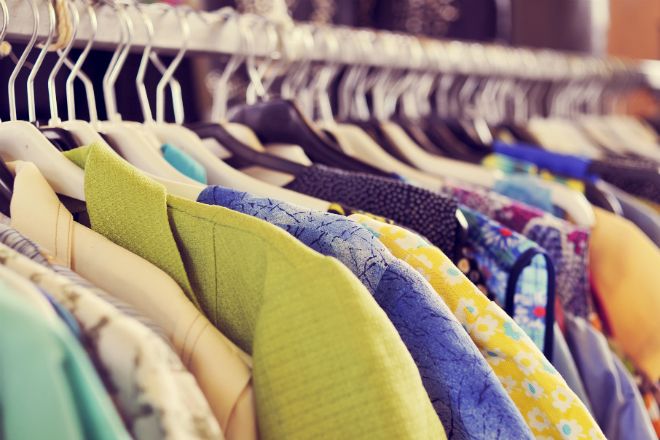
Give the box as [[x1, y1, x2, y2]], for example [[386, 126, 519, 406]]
[[67, 144, 446, 440]]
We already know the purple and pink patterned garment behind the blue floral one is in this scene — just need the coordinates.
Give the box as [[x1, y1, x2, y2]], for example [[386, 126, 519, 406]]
[[443, 181, 591, 317]]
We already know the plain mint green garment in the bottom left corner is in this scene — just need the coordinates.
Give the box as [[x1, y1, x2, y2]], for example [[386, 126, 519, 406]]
[[0, 272, 131, 440]]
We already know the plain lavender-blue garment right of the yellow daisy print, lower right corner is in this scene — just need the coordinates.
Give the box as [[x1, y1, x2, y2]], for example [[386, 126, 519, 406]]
[[565, 313, 658, 440]]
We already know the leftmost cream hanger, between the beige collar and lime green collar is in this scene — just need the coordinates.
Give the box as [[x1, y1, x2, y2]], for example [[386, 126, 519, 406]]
[[0, 0, 85, 200]]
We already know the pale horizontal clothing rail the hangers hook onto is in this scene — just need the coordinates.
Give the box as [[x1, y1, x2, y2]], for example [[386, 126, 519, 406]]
[[1, 0, 648, 89]]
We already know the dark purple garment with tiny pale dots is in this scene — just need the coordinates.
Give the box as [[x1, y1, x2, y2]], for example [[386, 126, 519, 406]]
[[286, 165, 457, 257]]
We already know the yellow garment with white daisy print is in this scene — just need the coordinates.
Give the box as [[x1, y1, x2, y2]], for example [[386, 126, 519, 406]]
[[349, 214, 605, 440]]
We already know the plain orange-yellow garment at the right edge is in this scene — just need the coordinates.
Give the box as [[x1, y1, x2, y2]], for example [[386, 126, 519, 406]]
[[589, 208, 660, 381]]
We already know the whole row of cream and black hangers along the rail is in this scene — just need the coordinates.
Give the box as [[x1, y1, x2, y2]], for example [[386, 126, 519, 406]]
[[0, 0, 648, 226]]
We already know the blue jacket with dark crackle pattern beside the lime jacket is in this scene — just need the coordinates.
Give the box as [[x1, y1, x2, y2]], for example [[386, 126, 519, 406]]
[[197, 186, 534, 440]]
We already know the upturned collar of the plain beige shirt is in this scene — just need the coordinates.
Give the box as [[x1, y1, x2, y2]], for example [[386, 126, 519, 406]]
[[8, 161, 73, 267]]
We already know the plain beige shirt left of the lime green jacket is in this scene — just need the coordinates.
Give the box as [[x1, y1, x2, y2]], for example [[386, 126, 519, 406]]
[[9, 161, 259, 440]]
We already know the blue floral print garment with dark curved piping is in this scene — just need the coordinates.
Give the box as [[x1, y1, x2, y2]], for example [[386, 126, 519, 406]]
[[460, 206, 555, 359]]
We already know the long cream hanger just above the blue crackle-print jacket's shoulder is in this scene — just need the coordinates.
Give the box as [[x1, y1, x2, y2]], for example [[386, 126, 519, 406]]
[[141, 7, 330, 211]]
